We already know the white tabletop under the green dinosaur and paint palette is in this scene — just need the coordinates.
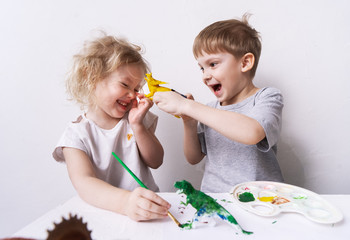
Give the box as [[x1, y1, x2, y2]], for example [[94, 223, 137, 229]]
[[13, 193, 350, 240]]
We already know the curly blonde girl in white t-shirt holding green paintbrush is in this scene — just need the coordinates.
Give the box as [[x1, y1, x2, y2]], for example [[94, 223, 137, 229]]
[[53, 33, 170, 221]]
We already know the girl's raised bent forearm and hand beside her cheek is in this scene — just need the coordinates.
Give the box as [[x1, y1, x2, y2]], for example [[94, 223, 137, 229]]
[[129, 94, 164, 168]]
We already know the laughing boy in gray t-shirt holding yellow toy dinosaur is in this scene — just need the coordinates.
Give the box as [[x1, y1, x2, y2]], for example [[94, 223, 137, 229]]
[[153, 14, 283, 192]]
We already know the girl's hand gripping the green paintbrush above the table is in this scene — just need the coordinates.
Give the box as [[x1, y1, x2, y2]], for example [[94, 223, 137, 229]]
[[126, 187, 170, 221]]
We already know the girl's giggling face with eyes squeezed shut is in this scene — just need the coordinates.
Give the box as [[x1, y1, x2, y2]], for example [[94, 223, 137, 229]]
[[93, 64, 144, 121]]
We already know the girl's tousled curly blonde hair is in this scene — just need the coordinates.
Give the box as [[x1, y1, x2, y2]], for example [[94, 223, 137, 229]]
[[66, 33, 149, 109]]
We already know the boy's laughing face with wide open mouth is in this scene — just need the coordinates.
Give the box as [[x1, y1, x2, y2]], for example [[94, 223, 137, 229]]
[[197, 52, 251, 106]]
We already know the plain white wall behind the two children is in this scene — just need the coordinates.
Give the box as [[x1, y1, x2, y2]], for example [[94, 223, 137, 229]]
[[0, 0, 350, 237]]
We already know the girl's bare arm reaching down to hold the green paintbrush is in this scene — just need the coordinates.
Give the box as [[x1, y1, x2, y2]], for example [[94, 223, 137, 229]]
[[63, 147, 170, 221]]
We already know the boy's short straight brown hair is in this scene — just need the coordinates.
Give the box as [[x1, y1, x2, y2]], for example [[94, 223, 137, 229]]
[[193, 14, 261, 77]]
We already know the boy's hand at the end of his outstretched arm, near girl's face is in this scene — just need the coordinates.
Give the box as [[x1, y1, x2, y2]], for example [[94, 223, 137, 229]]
[[153, 91, 187, 116]]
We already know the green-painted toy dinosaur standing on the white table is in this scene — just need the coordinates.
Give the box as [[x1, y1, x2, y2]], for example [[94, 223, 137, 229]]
[[174, 180, 253, 235]]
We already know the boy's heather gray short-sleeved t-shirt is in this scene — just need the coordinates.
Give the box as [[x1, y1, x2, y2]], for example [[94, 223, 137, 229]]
[[198, 87, 283, 193]]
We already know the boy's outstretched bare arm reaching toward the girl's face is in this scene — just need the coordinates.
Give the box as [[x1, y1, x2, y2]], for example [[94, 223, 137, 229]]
[[153, 92, 265, 145]]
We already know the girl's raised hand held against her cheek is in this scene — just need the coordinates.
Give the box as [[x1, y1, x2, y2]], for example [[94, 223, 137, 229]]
[[129, 93, 153, 125]]
